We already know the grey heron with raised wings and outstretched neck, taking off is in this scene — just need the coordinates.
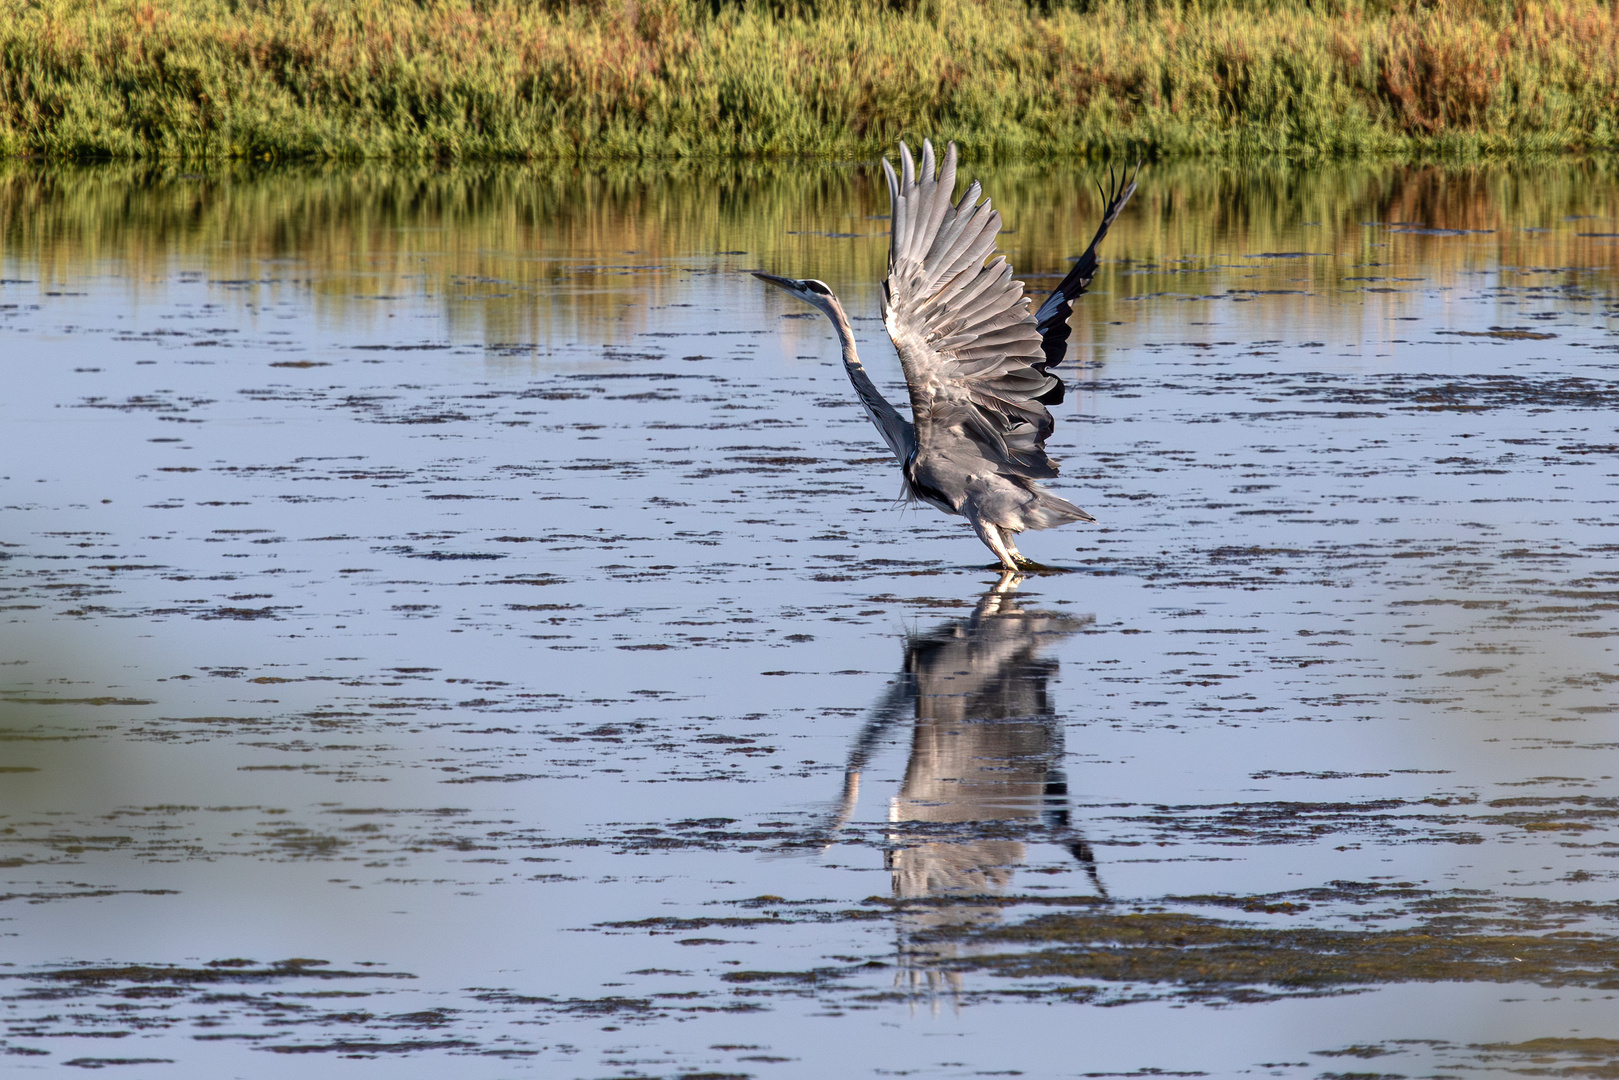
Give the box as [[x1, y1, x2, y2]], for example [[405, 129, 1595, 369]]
[[754, 141, 1140, 570]]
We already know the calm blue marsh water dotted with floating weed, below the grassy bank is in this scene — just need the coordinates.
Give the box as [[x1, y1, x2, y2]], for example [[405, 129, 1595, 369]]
[[0, 164, 1619, 1078]]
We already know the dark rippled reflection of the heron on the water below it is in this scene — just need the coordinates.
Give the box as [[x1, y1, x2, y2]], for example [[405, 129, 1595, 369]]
[[822, 573, 1107, 1003]]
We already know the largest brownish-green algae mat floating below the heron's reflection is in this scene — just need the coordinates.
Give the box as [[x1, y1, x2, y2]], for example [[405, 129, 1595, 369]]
[[907, 889, 1619, 1004]]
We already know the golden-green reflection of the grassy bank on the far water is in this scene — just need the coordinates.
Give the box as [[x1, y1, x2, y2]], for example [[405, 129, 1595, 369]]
[[0, 160, 1619, 345]]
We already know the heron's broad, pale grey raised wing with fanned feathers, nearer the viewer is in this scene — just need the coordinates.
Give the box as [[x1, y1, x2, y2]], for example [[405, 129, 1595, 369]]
[[882, 141, 1060, 478]]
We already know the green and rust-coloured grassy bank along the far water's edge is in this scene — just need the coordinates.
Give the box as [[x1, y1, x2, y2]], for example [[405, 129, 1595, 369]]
[[0, 0, 1619, 160]]
